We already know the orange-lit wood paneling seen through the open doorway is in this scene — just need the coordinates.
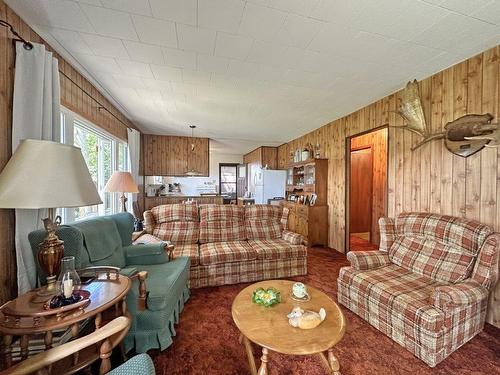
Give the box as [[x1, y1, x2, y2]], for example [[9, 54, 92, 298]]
[[351, 128, 388, 244]]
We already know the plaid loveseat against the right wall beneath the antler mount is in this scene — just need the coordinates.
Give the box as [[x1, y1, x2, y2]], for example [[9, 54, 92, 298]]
[[338, 213, 500, 367]]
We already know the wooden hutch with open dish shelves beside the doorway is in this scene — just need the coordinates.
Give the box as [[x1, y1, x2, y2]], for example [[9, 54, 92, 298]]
[[281, 159, 328, 246]]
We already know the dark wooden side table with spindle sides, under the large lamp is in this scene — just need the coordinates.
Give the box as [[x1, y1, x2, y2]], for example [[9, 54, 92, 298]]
[[0, 272, 132, 374]]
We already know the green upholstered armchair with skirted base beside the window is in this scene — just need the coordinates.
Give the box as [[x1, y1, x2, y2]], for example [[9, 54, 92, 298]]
[[28, 212, 189, 353]]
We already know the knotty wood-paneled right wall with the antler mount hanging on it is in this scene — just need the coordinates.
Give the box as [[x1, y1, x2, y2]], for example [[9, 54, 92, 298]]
[[278, 46, 500, 326]]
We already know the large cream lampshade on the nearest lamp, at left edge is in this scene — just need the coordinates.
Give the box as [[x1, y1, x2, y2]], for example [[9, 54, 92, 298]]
[[0, 139, 102, 209]]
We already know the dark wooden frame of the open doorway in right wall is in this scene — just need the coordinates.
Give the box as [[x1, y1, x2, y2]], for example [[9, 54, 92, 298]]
[[344, 124, 391, 254]]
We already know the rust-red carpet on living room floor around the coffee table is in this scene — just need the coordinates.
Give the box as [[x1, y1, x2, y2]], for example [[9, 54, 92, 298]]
[[150, 248, 500, 375]]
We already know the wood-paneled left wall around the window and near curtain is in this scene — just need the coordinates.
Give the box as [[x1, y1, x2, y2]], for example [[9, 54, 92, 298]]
[[0, 0, 134, 304]]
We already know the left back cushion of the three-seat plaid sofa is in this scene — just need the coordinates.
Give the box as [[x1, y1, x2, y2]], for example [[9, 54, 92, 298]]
[[151, 204, 200, 244]]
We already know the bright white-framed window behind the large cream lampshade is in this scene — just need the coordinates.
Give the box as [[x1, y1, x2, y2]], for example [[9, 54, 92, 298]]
[[61, 109, 129, 223]]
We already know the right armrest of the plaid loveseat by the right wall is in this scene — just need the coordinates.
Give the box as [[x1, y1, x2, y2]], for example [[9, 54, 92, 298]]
[[430, 279, 488, 311]]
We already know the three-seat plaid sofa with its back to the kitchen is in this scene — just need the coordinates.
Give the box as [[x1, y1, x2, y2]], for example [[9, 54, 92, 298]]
[[144, 204, 307, 288]]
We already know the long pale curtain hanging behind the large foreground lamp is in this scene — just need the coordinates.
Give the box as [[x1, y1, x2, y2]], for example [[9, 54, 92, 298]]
[[12, 42, 60, 294]]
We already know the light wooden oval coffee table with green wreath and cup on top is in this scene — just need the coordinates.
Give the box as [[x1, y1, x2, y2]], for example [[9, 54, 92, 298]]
[[232, 280, 346, 375]]
